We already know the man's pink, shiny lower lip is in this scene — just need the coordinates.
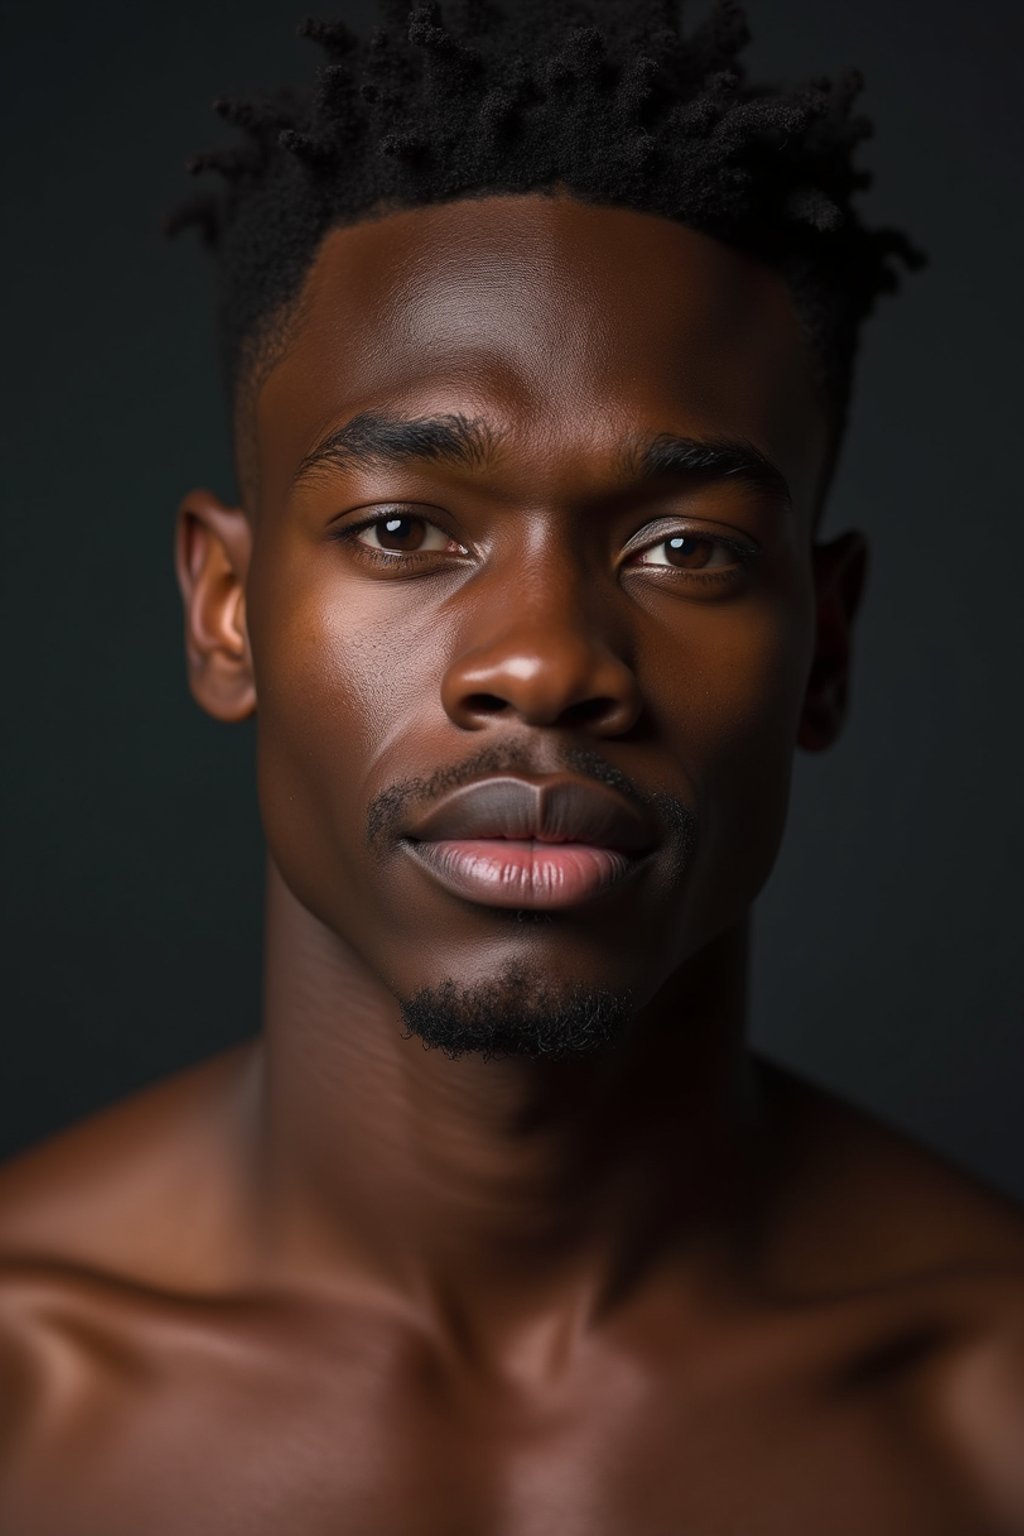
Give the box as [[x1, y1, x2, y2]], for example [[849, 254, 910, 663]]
[[405, 837, 639, 908]]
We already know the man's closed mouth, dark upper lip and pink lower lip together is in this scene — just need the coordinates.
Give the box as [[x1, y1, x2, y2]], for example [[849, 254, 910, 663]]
[[402, 777, 656, 909]]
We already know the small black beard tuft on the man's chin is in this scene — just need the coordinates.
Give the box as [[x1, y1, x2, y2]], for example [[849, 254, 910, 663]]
[[401, 960, 633, 1061]]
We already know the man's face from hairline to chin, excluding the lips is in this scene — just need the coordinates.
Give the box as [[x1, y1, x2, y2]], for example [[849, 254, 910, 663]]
[[231, 195, 827, 1056]]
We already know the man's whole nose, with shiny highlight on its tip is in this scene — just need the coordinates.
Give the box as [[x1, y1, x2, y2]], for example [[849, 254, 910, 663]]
[[442, 538, 640, 733]]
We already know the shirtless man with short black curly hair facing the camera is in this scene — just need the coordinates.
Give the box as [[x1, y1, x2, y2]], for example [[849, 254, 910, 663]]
[[0, 0, 1024, 1536]]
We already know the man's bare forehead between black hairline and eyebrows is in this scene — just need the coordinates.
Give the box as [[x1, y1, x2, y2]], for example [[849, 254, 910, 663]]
[[256, 194, 827, 519]]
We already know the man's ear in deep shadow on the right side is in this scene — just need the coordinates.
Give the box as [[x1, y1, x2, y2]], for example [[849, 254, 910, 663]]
[[797, 531, 867, 753]]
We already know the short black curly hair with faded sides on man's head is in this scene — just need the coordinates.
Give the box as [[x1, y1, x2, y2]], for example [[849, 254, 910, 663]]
[[166, 0, 926, 509]]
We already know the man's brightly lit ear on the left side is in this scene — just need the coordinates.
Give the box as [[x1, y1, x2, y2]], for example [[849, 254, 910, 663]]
[[173, 490, 256, 720]]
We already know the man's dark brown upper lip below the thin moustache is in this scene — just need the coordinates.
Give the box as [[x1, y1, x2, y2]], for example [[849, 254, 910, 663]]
[[405, 776, 656, 854]]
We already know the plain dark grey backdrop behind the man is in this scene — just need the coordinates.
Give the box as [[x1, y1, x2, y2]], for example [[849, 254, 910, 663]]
[[0, 0, 1024, 1200]]
